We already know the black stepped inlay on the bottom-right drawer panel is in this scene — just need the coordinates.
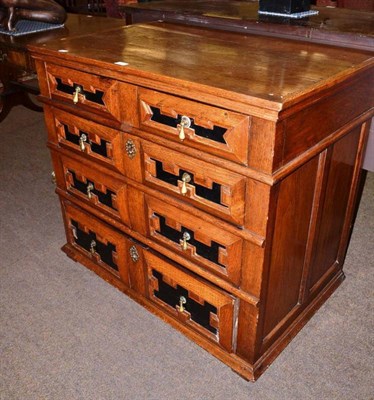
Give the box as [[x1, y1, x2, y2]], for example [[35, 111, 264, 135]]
[[152, 269, 218, 335]]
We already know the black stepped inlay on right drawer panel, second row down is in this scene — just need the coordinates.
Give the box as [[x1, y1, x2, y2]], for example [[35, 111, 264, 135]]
[[151, 158, 227, 207]]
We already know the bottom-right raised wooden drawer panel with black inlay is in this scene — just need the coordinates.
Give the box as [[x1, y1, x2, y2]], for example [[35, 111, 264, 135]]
[[144, 252, 235, 351]]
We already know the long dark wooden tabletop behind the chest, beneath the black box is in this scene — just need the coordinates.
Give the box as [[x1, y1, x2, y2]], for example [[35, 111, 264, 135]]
[[119, 0, 374, 50]]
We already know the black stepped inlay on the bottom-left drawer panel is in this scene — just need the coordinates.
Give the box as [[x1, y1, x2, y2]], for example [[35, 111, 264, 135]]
[[70, 219, 118, 271]]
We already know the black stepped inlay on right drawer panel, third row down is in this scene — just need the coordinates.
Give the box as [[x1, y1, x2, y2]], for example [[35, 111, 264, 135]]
[[154, 213, 226, 268]]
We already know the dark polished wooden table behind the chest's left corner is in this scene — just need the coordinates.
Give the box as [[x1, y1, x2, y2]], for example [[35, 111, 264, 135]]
[[0, 14, 124, 122]]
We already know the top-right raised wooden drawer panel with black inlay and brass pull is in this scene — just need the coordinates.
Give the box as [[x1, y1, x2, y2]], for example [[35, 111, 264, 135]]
[[139, 88, 250, 165]]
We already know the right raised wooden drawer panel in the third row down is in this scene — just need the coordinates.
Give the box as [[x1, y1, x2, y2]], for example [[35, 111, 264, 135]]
[[145, 196, 243, 285]]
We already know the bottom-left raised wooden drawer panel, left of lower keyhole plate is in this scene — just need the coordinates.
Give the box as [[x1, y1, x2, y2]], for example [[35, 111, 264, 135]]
[[63, 202, 129, 285]]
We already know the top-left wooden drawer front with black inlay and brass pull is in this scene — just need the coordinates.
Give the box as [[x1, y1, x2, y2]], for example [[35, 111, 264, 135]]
[[46, 64, 138, 126]]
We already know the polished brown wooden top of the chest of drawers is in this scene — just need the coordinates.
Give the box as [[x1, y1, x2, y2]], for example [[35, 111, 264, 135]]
[[29, 23, 374, 111]]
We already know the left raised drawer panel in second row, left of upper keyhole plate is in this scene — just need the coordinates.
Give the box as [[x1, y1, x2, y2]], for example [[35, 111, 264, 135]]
[[45, 106, 124, 173]]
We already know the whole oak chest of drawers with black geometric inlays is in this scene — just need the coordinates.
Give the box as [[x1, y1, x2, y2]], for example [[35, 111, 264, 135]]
[[30, 23, 374, 380]]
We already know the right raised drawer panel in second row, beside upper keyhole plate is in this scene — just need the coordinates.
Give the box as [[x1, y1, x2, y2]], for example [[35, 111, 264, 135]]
[[124, 135, 246, 226]]
